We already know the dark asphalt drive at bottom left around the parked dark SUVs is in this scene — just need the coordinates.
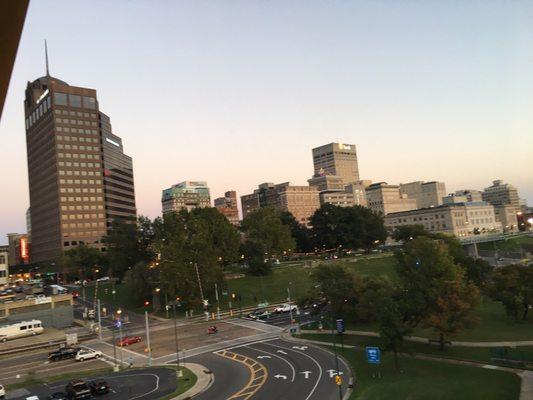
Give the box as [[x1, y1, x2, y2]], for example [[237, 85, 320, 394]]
[[8, 368, 176, 400]]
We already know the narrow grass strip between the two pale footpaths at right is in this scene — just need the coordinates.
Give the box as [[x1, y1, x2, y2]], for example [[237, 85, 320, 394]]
[[302, 333, 533, 368]]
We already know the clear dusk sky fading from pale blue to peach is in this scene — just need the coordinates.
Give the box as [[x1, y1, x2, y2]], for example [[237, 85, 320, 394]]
[[0, 0, 533, 243]]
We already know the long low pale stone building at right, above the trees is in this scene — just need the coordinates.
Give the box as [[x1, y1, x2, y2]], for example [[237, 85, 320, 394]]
[[385, 202, 502, 237]]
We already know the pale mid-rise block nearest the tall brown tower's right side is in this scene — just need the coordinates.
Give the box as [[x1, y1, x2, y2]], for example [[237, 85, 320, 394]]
[[161, 181, 211, 214]]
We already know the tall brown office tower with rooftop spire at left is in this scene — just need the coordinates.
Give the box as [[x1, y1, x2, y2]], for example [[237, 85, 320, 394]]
[[24, 66, 136, 262]]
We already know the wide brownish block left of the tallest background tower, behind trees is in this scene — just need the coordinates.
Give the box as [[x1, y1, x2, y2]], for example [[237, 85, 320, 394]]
[[241, 182, 320, 225]]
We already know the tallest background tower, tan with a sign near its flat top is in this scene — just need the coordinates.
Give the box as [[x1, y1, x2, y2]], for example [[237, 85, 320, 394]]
[[313, 143, 359, 184]]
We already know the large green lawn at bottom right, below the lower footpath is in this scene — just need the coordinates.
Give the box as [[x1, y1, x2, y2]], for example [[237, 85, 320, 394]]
[[320, 347, 521, 400]]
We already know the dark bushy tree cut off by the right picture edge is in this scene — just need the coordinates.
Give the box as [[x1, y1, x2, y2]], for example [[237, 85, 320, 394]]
[[489, 265, 533, 320]]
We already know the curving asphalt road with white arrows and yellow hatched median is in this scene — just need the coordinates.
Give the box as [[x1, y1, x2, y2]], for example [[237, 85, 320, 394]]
[[187, 339, 350, 400]]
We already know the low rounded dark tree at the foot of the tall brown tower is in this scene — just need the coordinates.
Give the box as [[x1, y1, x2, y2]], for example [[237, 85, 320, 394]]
[[59, 244, 104, 279]]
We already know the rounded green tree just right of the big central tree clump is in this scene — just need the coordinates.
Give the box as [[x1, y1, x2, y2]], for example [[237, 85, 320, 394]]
[[241, 207, 295, 275]]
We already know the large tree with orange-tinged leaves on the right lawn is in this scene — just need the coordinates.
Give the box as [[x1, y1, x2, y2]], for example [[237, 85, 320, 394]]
[[397, 236, 479, 348]]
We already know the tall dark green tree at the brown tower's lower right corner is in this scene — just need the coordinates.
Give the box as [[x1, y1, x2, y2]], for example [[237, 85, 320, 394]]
[[103, 216, 154, 280]]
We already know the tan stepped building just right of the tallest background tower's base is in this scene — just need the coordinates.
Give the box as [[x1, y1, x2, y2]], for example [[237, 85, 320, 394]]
[[366, 182, 417, 215]]
